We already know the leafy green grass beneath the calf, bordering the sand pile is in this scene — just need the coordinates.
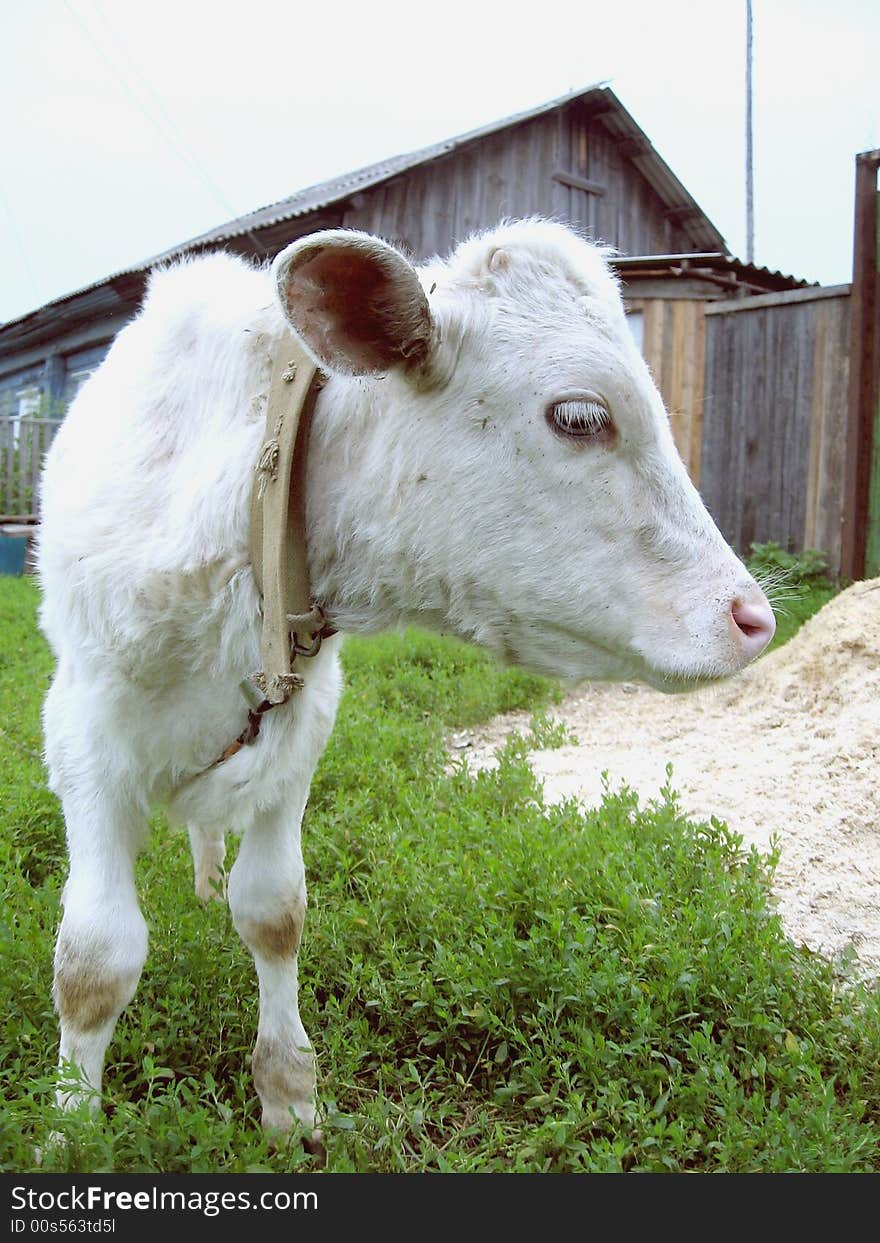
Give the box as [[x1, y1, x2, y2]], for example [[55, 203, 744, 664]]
[[0, 579, 880, 1172]]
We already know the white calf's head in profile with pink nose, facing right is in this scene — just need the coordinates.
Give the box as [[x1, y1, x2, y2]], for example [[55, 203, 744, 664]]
[[273, 220, 774, 690]]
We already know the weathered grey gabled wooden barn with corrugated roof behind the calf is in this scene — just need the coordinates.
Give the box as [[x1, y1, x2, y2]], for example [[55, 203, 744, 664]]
[[0, 87, 740, 427]]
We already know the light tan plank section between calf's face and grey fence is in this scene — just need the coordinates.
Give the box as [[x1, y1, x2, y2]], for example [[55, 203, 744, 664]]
[[626, 297, 708, 487]]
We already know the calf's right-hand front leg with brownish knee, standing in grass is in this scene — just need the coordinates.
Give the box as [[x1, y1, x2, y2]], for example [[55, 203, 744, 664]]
[[229, 805, 321, 1151]]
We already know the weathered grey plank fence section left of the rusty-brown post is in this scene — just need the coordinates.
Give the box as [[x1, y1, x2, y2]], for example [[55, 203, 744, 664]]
[[700, 286, 849, 573]]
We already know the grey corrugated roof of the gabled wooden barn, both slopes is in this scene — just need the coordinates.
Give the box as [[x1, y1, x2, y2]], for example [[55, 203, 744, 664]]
[[0, 83, 727, 333]]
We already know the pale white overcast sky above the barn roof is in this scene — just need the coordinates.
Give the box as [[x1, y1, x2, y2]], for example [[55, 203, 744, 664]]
[[0, 0, 880, 321]]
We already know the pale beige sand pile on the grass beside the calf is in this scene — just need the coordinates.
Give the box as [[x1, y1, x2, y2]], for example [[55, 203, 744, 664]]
[[451, 579, 880, 978]]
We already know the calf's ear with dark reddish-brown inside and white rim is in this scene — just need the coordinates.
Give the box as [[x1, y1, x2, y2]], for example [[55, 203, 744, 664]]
[[272, 229, 433, 375]]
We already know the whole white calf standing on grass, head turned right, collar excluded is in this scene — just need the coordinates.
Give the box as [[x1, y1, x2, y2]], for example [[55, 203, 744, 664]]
[[40, 221, 773, 1134]]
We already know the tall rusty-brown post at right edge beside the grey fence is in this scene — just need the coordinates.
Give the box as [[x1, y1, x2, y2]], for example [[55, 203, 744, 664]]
[[840, 150, 880, 579]]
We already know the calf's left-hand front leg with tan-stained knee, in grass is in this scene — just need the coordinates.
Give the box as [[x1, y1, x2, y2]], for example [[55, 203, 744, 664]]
[[53, 794, 147, 1110]]
